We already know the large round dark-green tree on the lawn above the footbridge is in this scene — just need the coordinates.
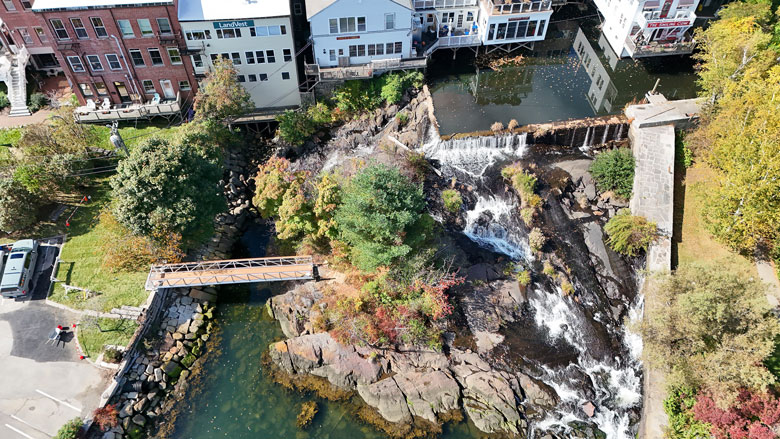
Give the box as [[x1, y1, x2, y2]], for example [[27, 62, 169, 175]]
[[111, 138, 225, 239]]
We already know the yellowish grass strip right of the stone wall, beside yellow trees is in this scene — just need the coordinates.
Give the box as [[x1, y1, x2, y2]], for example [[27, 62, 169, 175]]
[[674, 163, 758, 277]]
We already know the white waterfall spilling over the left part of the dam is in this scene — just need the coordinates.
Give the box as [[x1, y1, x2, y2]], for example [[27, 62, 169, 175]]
[[423, 133, 527, 178]]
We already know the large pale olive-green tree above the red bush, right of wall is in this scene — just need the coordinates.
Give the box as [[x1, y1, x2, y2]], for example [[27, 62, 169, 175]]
[[641, 266, 780, 405]]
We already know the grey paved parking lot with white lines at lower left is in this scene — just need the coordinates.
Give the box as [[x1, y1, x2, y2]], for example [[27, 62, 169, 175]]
[[0, 240, 111, 439]]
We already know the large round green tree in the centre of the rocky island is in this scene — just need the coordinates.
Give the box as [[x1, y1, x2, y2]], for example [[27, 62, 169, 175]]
[[335, 165, 433, 272]]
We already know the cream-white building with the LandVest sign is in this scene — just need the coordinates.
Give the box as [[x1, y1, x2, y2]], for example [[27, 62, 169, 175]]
[[178, 0, 301, 110]]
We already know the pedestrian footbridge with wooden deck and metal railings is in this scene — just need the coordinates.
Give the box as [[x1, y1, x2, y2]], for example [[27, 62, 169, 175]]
[[146, 256, 316, 291]]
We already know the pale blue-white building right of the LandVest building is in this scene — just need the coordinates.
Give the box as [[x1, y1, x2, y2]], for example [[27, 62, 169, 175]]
[[306, 0, 413, 68]]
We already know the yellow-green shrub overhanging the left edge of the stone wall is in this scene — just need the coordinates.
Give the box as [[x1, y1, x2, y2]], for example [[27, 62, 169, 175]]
[[604, 209, 658, 256]]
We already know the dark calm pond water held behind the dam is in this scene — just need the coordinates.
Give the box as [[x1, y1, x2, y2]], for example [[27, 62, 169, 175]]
[[429, 8, 697, 134]]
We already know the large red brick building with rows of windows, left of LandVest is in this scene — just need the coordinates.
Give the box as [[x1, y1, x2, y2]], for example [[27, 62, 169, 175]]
[[32, 0, 197, 106]]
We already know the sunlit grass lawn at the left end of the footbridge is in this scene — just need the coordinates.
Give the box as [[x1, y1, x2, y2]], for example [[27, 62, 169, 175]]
[[49, 179, 148, 311]]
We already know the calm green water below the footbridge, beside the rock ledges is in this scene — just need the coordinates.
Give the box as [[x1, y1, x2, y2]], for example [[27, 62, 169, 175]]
[[168, 228, 479, 439]]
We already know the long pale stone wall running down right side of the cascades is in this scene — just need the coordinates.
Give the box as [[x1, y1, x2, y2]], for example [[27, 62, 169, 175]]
[[626, 94, 700, 439]]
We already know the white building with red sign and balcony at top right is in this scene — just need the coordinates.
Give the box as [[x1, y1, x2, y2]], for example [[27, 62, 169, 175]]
[[594, 0, 699, 58]]
